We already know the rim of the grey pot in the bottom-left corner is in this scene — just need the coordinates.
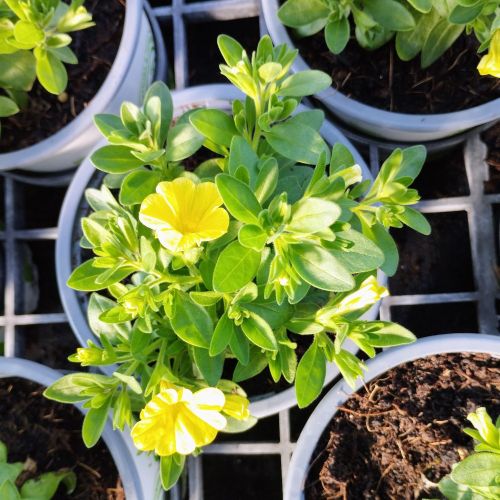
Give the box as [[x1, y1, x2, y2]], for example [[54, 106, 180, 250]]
[[0, 357, 156, 500]]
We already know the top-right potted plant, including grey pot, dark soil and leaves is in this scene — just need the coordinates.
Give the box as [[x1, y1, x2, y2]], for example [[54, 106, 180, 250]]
[[262, 0, 500, 142]]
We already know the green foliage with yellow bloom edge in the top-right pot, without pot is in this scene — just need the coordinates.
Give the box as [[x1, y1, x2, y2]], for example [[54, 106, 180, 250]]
[[278, 0, 500, 77]]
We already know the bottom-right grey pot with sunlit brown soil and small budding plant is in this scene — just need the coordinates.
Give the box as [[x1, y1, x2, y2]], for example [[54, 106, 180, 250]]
[[284, 334, 500, 500]]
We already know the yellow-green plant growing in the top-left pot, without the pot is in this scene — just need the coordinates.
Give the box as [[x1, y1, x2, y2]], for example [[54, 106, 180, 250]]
[[0, 0, 94, 131]]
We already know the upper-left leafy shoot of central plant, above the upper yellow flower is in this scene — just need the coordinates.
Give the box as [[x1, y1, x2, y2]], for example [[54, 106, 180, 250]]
[[91, 82, 204, 202]]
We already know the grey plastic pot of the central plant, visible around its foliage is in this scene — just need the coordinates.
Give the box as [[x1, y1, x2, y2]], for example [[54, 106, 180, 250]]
[[56, 84, 386, 418]]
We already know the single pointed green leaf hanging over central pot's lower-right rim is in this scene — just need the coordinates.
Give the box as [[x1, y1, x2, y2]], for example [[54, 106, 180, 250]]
[[295, 339, 326, 408]]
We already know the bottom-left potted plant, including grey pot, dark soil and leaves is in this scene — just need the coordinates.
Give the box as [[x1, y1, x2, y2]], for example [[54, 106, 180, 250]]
[[0, 357, 166, 500]]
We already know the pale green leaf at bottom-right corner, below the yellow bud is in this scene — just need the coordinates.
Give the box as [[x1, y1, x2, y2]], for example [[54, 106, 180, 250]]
[[450, 452, 500, 487]]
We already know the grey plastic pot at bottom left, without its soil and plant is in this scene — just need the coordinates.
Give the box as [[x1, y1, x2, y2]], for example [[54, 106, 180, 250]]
[[0, 357, 167, 500]]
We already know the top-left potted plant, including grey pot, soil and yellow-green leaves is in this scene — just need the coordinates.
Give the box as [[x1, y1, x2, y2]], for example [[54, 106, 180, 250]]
[[0, 0, 165, 171]]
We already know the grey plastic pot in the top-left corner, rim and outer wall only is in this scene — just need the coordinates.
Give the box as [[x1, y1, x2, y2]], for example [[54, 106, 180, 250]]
[[0, 0, 162, 172]]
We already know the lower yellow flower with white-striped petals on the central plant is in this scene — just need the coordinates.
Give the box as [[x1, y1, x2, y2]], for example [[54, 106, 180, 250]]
[[132, 382, 227, 457]]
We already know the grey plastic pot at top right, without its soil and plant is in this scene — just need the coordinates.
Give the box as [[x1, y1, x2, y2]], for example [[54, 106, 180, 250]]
[[262, 0, 500, 143]]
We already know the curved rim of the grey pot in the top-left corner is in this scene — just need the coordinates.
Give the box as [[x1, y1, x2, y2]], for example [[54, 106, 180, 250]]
[[0, 0, 145, 170]]
